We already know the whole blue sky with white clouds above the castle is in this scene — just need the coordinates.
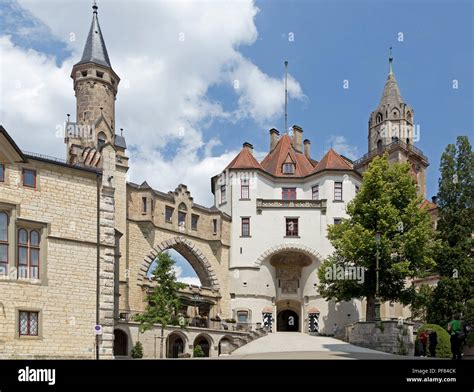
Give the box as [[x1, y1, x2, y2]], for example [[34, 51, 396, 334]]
[[0, 0, 474, 282]]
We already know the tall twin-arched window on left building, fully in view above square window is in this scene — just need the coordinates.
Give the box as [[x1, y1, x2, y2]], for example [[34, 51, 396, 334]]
[[18, 229, 40, 279]]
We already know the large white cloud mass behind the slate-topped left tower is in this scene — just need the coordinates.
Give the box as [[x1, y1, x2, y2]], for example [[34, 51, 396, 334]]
[[0, 0, 304, 205]]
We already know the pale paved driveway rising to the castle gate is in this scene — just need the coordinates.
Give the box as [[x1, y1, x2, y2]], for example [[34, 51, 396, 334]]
[[230, 332, 400, 359]]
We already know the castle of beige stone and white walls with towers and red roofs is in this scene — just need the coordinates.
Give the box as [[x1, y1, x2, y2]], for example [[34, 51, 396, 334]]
[[0, 5, 435, 358]]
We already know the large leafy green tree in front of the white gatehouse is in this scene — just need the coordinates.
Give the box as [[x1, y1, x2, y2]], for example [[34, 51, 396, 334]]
[[318, 155, 434, 321]]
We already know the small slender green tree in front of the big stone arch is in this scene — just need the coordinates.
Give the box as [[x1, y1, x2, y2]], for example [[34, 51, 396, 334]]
[[136, 252, 186, 358]]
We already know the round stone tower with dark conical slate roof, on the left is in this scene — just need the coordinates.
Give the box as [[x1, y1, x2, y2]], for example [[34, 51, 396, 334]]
[[65, 3, 120, 159]]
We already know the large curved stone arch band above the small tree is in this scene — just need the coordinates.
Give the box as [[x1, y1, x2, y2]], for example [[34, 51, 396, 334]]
[[138, 236, 219, 290]]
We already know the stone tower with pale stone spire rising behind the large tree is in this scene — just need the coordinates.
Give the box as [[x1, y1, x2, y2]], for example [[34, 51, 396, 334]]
[[354, 48, 429, 196]]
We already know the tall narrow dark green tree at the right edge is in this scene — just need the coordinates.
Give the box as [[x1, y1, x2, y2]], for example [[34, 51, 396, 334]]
[[428, 136, 474, 326]]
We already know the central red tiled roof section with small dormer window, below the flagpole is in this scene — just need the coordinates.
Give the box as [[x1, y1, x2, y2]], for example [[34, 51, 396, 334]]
[[261, 134, 314, 177]]
